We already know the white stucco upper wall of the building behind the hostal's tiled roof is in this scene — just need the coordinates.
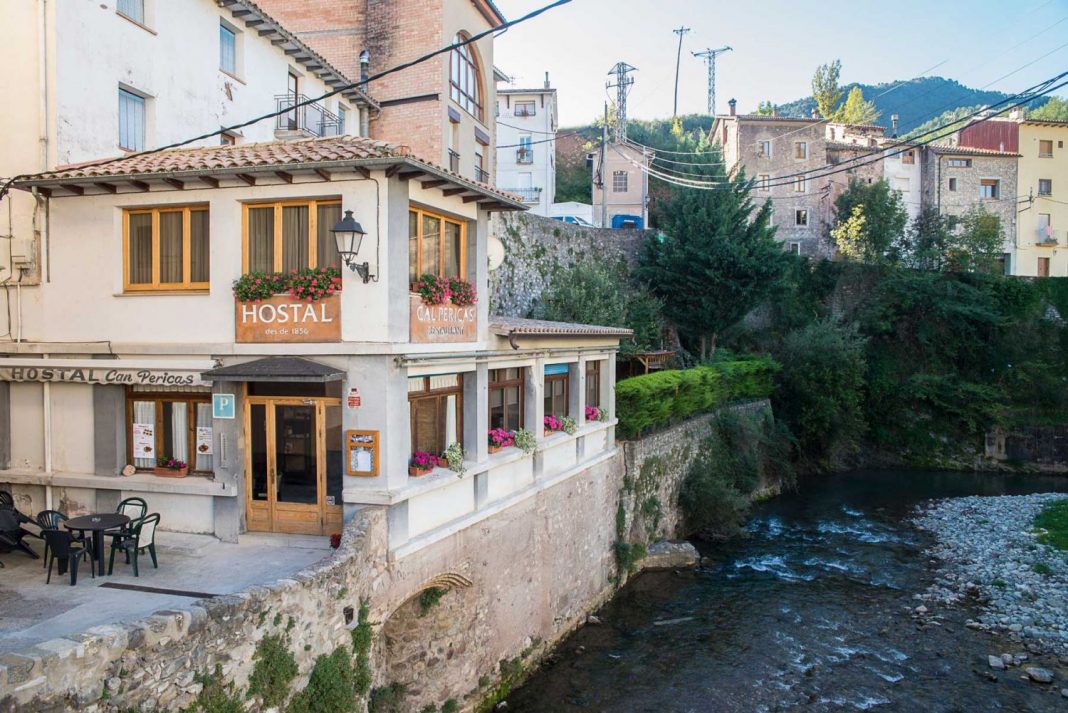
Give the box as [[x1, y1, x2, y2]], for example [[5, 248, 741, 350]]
[[53, 0, 359, 164]]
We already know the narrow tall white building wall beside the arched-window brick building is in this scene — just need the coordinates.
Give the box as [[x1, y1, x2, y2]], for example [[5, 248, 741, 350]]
[[497, 89, 557, 216]]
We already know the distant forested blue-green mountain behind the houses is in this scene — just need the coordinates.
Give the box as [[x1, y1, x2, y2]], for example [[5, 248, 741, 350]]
[[776, 77, 1048, 134]]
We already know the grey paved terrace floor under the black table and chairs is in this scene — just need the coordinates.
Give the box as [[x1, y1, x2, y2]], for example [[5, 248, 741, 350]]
[[0, 530, 331, 653]]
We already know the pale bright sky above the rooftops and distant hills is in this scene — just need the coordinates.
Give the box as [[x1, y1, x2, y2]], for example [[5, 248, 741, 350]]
[[494, 0, 1068, 127]]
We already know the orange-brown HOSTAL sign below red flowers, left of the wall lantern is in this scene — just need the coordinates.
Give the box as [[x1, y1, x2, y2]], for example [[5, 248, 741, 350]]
[[234, 295, 341, 344]]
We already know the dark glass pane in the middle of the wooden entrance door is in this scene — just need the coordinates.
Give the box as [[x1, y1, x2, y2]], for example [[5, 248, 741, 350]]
[[274, 403, 318, 505]]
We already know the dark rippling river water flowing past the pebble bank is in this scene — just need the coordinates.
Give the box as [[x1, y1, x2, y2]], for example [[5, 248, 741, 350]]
[[507, 472, 1068, 713]]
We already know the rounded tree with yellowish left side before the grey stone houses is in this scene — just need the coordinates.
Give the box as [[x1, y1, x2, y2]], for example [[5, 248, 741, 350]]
[[831, 178, 909, 265]]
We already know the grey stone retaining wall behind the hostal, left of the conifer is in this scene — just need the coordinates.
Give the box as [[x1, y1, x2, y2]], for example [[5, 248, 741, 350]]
[[489, 212, 644, 317]]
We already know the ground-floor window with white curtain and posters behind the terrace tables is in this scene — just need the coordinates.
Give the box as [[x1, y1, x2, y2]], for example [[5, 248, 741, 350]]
[[126, 393, 215, 473]]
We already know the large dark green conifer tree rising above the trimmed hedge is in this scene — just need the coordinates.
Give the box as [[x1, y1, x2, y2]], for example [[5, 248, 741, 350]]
[[638, 149, 788, 359]]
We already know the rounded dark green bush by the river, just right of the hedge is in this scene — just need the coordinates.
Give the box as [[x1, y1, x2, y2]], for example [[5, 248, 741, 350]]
[[772, 319, 867, 468]]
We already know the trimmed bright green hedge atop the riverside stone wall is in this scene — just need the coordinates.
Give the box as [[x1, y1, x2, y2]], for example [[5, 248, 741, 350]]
[[615, 357, 780, 439]]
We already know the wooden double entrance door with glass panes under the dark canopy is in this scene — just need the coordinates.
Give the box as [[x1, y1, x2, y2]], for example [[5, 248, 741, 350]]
[[245, 396, 343, 535]]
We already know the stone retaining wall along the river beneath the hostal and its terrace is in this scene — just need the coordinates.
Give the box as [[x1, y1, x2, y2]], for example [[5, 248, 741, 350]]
[[0, 400, 774, 713]]
